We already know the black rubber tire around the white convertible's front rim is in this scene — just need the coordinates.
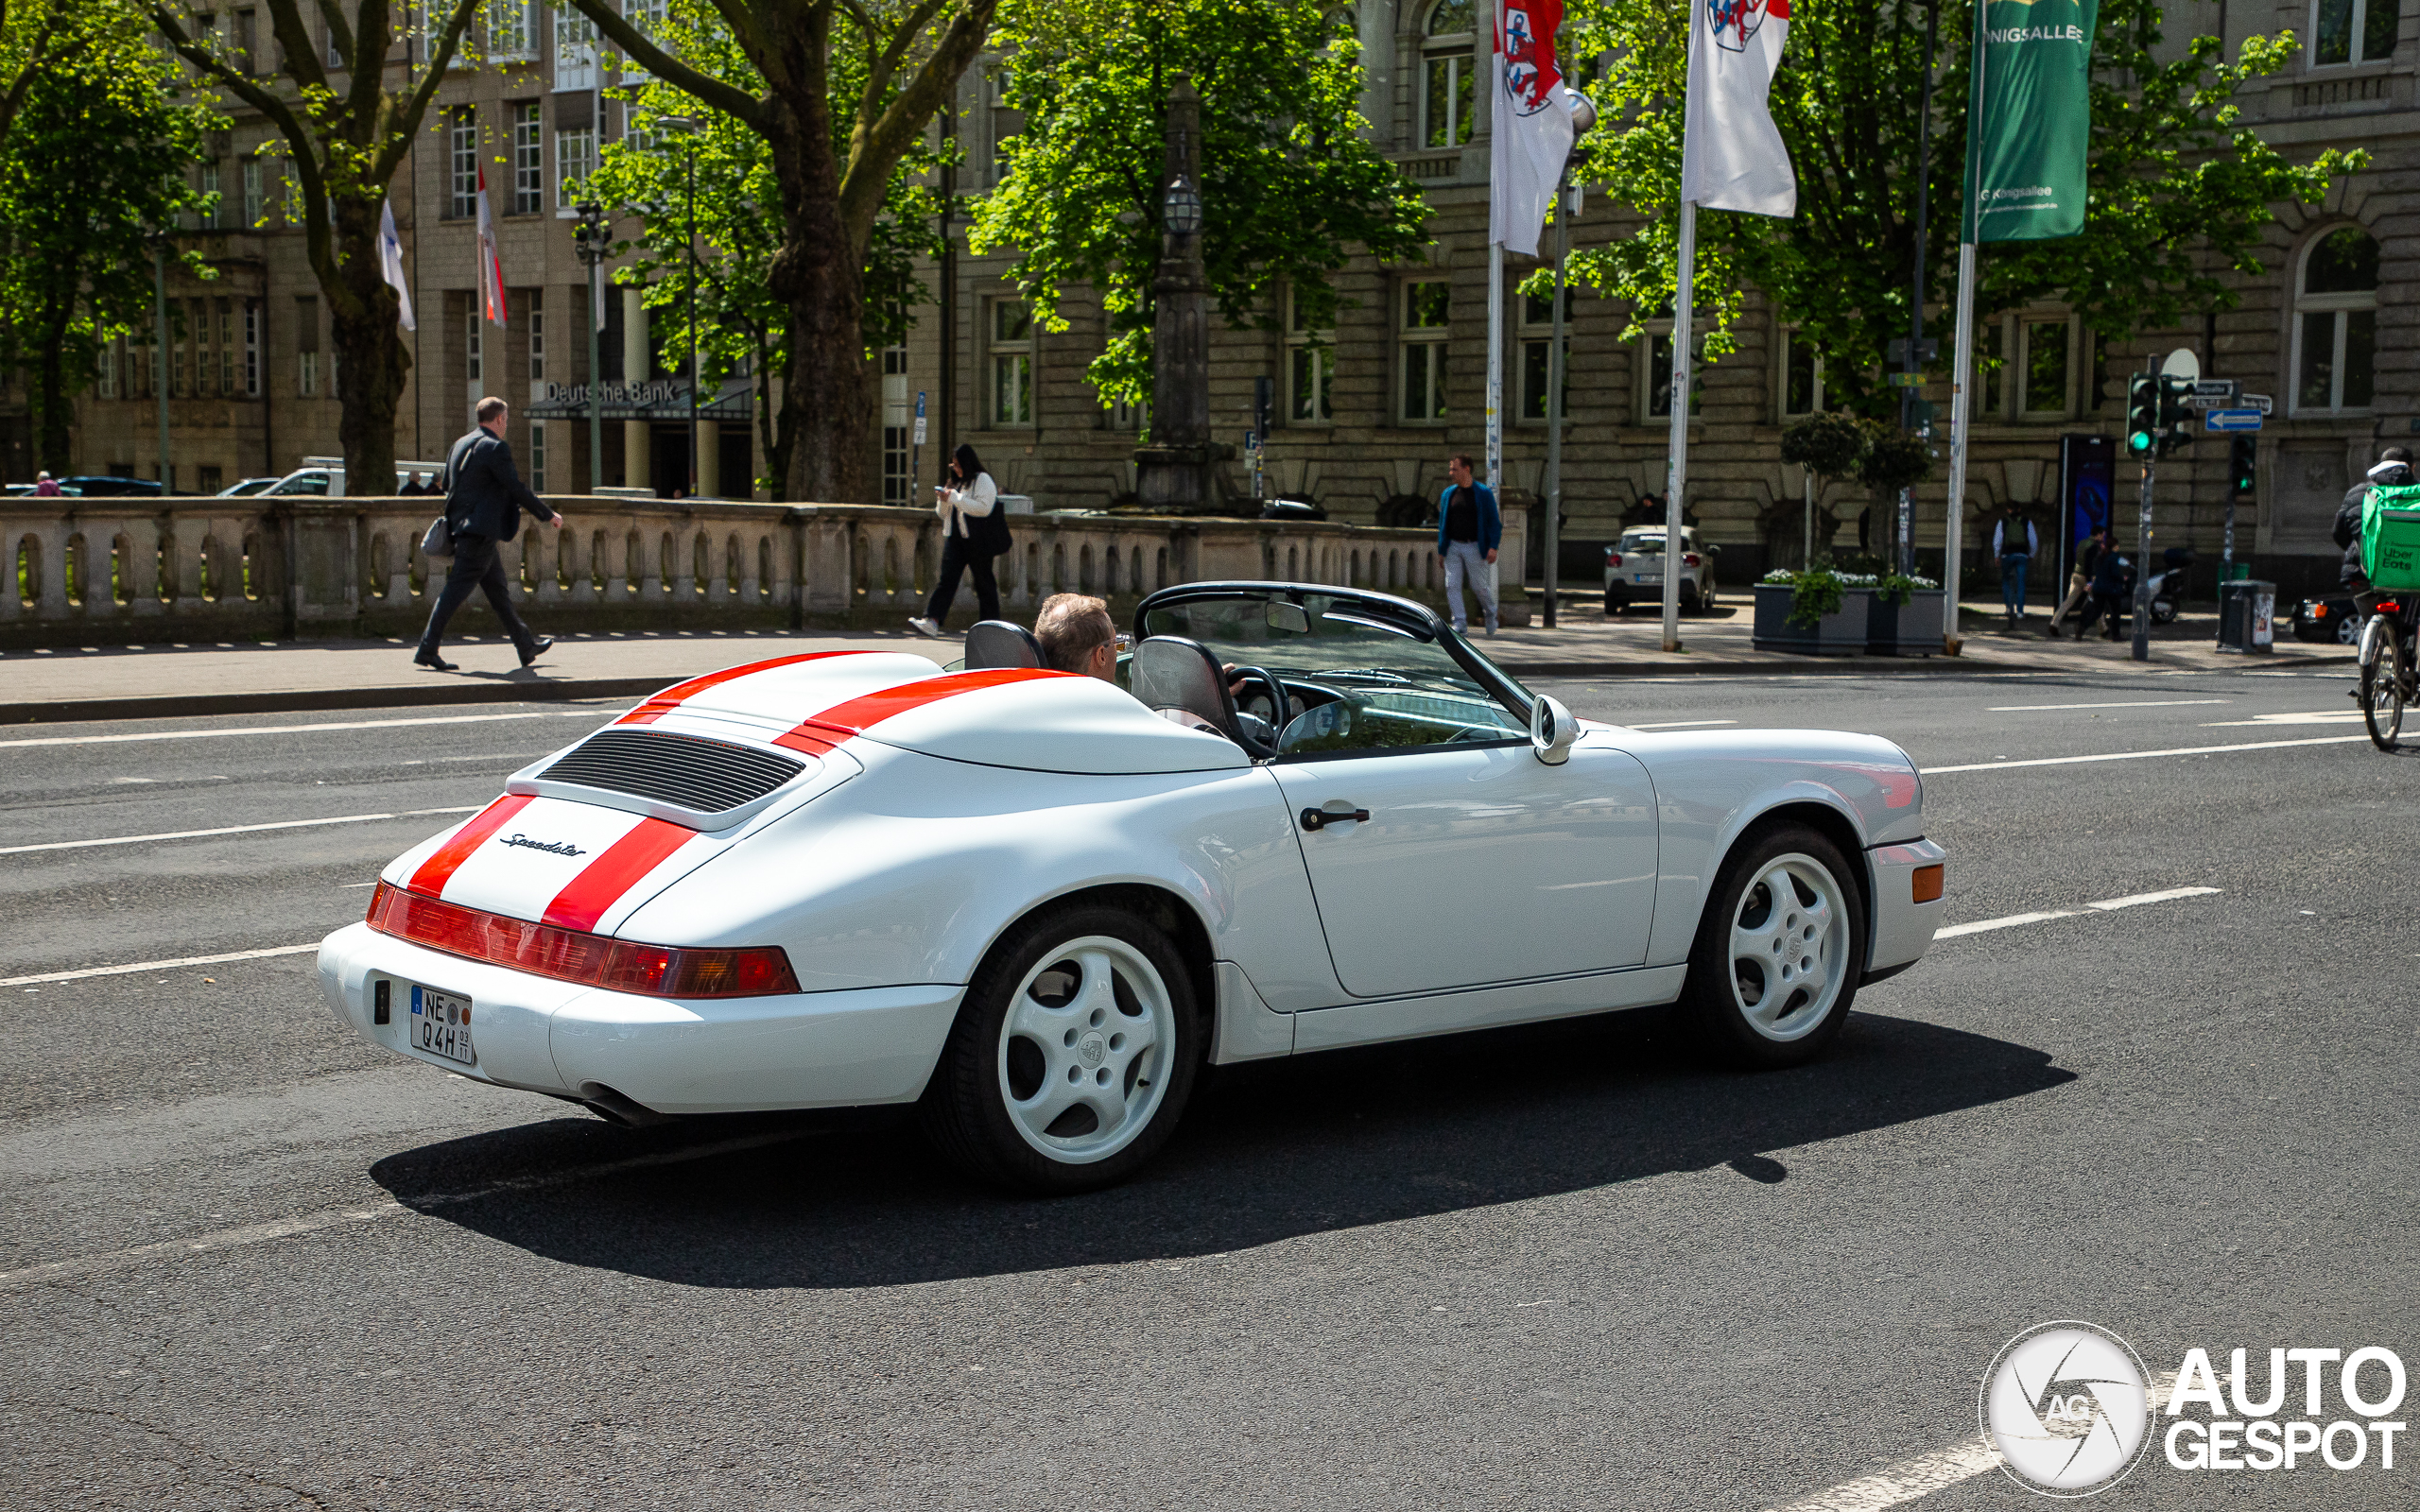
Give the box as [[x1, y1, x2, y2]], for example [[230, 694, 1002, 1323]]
[[1677, 822, 1866, 1070]]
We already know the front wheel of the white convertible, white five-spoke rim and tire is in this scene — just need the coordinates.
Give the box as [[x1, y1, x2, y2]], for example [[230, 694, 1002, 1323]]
[[1680, 825, 1866, 1067]]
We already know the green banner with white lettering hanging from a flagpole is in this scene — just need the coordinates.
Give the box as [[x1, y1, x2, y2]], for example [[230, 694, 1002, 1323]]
[[1961, 0, 2100, 242]]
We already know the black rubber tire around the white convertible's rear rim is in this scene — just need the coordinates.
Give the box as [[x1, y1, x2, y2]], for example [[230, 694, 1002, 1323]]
[[917, 904, 1207, 1195]]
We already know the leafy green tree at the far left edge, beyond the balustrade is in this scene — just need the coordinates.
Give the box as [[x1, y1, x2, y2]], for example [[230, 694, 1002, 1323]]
[[0, 34, 208, 472]]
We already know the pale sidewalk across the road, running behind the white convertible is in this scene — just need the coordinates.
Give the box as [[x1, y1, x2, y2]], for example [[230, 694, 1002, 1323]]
[[0, 593, 2352, 723]]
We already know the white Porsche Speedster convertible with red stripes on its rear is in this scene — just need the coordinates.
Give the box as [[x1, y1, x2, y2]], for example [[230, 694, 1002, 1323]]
[[320, 583, 1944, 1193]]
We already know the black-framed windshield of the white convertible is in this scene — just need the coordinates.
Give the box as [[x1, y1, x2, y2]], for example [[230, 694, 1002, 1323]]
[[1142, 593, 1530, 752]]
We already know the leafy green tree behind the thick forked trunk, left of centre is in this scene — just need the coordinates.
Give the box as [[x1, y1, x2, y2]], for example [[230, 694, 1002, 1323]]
[[586, 5, 943, 498]]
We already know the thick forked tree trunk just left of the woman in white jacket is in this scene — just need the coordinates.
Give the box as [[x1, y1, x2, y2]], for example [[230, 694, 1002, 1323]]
[[571, 0, 994, 501]]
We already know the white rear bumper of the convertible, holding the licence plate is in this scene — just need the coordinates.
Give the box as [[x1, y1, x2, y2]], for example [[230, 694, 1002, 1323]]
[[320, 924, 965, 1113]]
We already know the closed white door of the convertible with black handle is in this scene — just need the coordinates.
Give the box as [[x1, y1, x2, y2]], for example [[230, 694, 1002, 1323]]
[[1270, 735, 1655, 997]]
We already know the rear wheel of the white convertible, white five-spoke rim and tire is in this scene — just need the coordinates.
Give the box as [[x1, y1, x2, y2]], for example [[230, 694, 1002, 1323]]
[[922, 904, 1202, 1195]]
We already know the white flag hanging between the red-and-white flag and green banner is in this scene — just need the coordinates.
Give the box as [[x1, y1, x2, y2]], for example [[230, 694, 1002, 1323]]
[[1680, 0, 1798, 217]]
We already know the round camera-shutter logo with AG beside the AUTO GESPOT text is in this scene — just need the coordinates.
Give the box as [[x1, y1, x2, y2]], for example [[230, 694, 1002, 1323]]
[[1979, 1321, 2152, 1498]]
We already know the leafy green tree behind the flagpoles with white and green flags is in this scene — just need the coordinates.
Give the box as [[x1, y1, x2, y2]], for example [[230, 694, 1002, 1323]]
[[1531, 0, 2364, 414]]
